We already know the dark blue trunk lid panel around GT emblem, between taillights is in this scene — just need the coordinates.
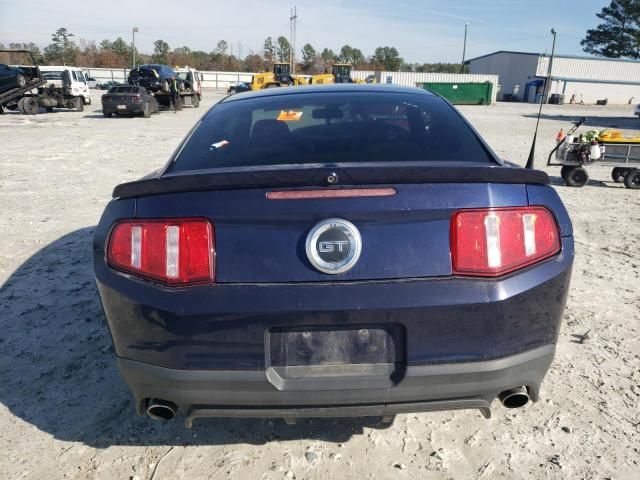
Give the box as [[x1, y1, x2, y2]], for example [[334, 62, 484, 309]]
[[129, 167, 527, 283]]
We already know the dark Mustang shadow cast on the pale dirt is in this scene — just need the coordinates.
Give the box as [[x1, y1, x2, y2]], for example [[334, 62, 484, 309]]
[[0, 228, 379, 448]]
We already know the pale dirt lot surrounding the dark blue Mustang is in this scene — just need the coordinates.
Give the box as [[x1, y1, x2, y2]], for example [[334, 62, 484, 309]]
[[0, 93, 640, 480]]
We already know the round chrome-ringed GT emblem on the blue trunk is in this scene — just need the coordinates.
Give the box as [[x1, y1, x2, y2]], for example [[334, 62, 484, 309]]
[[305, 218, 362, 275]]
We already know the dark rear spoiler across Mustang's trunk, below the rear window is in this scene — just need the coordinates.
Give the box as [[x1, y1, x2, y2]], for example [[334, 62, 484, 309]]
[[113, 162, 549, 198]]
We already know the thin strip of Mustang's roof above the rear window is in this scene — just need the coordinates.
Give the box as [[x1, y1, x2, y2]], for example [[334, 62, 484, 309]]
[[222, 83, 434, 102]]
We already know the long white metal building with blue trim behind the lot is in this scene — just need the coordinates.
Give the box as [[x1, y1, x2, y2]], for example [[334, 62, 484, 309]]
[[465, 51, 640, 104]]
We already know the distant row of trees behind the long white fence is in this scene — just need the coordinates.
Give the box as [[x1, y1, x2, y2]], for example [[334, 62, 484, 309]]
[[0, 27, 461, 74]]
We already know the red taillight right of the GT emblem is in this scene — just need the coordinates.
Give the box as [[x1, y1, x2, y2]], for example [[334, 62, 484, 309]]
[[451, 207, 560, 277]]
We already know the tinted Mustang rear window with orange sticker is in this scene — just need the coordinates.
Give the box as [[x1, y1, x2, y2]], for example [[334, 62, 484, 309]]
[[171, 91, 492, 171]]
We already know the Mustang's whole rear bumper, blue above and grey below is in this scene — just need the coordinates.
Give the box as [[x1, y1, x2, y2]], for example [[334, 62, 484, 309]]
[[94, 237, 573, 421]]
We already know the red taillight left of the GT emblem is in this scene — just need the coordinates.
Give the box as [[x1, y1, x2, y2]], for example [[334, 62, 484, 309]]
[[107, 218, 215, 285]]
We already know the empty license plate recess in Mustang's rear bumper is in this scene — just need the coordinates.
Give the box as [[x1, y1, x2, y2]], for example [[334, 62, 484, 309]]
[[266, 324, 406, 390]]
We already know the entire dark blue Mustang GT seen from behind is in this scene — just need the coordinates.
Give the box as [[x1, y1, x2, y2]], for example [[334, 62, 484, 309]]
[[94, 84, 573, 425]]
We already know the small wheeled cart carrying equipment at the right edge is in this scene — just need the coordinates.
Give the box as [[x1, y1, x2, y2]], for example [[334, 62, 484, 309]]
[[547, 118, 640, 189]]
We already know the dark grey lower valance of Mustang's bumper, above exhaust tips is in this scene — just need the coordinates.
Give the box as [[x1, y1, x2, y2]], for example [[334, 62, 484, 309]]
[[118, 345, 555, 426]]
